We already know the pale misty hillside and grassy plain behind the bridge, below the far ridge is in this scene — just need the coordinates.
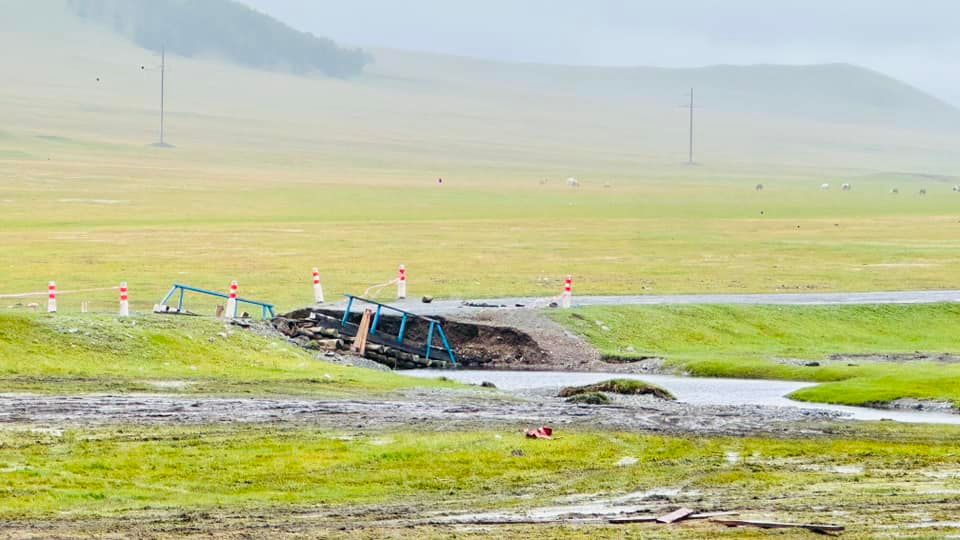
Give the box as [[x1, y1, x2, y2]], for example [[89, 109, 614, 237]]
[[0, 9, 960, 313]]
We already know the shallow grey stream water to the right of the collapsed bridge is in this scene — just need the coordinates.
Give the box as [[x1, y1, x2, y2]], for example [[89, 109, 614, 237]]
[[403, 369, 960, 425]]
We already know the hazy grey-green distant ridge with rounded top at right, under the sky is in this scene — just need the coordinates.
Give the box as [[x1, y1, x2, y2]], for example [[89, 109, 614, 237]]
[[374, 49, 960, 132]]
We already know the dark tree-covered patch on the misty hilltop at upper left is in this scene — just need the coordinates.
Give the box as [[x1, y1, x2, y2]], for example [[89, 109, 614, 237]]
[[67, 0, 372, 77]]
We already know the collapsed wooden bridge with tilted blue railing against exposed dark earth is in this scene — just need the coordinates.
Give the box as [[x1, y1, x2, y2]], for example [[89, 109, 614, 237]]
[[273, 296, 548, 369]]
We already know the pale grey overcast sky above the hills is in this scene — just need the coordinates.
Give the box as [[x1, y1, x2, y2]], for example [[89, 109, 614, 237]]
[[242, 0, 960, 104]]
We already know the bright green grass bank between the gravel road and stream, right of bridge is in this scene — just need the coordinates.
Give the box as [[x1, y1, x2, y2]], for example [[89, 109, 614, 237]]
[[553, 304, 960, 406]]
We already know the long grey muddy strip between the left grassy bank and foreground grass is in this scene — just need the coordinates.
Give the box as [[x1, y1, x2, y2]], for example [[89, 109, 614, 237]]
[[0, 391, 840, 436]]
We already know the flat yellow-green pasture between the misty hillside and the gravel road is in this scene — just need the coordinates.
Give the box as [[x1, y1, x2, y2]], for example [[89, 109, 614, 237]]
[[0, 133, 960, 313]]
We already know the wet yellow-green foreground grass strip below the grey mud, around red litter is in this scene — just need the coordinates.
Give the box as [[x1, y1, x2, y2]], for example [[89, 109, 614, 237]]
[[0, 426, 960, 519]]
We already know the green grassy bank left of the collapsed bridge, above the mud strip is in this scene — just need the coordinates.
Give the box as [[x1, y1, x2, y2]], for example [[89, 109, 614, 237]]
[[0, 314, 455, 396]]
